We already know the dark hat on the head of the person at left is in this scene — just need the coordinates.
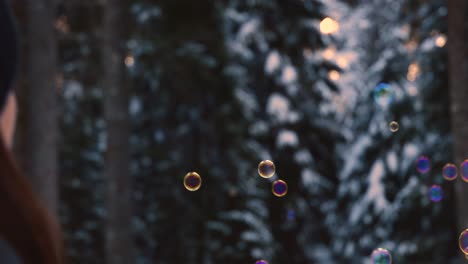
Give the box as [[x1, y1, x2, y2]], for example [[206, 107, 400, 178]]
[[0, 0, 18, 110]]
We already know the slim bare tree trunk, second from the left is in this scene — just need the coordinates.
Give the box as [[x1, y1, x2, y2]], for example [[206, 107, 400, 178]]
[[102, 0, 134, 264]]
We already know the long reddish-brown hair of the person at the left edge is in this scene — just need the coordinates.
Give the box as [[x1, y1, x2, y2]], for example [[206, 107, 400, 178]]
[[0, 137, 63, 264]]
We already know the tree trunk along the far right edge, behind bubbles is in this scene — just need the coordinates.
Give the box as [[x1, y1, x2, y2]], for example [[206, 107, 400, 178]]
[[448, 0, 468, 260]]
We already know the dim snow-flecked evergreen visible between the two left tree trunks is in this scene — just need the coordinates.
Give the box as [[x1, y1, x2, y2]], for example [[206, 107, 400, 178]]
[[55, 1, 105, 264]]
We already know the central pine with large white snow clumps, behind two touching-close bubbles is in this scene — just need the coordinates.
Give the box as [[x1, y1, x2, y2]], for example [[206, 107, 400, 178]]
[[216, 0, 341, 263]]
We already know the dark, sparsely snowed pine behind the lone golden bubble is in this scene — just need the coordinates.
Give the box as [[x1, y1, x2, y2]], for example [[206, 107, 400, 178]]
[[129, 1, 264, 264]]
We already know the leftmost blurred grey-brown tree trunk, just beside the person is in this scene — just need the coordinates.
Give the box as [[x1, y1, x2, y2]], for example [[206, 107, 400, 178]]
[[19, 0, 58, 213]]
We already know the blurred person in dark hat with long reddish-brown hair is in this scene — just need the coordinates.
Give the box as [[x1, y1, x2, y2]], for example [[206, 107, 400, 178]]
[[0, 0, 63, 264]]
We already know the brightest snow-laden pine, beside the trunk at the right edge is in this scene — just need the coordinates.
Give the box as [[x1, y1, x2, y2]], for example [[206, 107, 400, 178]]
[[327, 0, 456, 263]]
